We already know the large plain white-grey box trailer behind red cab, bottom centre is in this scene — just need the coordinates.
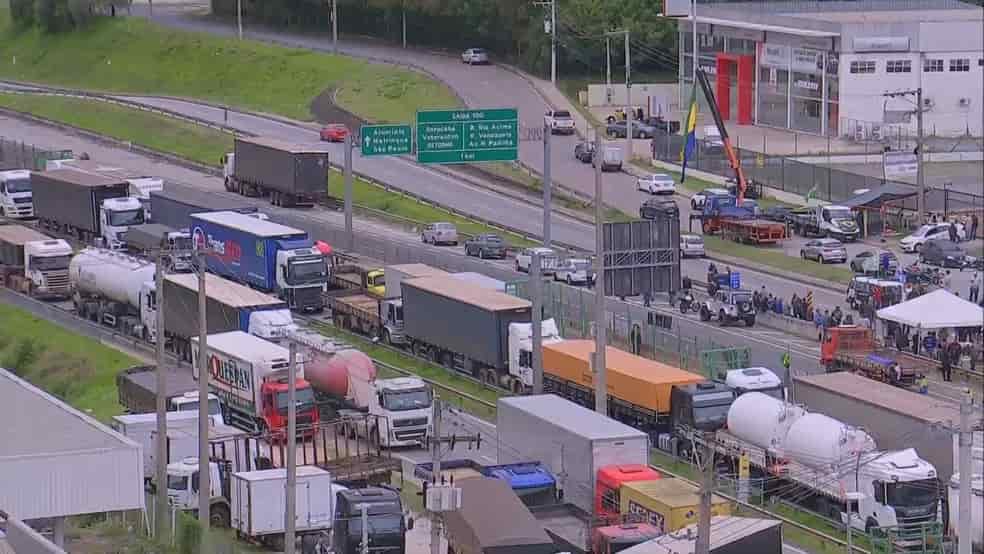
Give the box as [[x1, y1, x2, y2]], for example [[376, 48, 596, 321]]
[[496, 394, 649, 513]]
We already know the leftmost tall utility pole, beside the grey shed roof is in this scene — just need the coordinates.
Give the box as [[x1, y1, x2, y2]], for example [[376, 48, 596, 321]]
[[154, 248, 167, 540]]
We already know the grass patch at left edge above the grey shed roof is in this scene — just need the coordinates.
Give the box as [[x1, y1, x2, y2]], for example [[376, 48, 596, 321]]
[[0, 304, 138, 421]]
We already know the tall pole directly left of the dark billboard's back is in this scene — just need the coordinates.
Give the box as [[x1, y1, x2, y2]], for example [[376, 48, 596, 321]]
[[592, 130, 608, 415]]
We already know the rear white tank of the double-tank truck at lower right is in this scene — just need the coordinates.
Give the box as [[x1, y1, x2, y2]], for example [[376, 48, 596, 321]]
[[728, 392, 806, 457]]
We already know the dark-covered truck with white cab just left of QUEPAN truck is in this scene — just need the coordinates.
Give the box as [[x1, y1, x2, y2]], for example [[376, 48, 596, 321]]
[[116, 365, 225, 425]]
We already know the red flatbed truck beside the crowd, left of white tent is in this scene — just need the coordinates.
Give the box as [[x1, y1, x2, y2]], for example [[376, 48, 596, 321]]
[[820, 325, 937, 387]]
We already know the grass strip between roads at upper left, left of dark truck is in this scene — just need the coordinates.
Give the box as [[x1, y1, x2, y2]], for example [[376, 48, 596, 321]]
[[0, 93, 232, 165]]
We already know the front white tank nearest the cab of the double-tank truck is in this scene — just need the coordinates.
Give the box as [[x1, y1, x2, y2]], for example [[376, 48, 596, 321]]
[[785, 413, 877, 469]]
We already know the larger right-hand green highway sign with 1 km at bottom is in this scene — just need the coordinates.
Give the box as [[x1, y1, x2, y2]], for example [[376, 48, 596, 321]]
[[417, 108, 519, 164]]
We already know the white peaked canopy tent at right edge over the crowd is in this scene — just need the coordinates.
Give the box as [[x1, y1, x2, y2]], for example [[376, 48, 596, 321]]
[[878, 289, 984, 329]]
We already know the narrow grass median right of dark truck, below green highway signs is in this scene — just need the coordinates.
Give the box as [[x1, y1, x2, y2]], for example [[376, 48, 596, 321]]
[[328, 171, 536, 247]]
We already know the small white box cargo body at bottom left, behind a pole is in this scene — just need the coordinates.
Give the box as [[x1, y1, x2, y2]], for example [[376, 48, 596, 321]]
[[229, 466, 345, 543]]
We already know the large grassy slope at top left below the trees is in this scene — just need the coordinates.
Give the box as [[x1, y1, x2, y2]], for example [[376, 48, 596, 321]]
[[0, 8, 458, 122]]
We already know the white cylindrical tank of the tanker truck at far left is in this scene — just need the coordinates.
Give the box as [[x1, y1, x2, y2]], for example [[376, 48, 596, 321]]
[[68, 248, 157, 308]]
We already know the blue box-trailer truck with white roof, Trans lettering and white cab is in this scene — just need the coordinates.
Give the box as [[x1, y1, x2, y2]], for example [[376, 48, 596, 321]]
[[191, 212, 328, 312]]
